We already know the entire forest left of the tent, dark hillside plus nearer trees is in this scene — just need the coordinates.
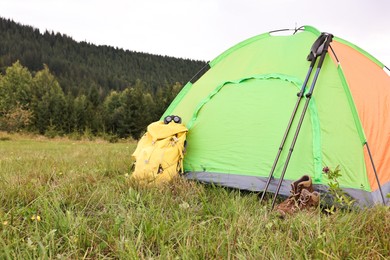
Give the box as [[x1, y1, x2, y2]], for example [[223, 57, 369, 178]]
[[0, 18, 206, 139]]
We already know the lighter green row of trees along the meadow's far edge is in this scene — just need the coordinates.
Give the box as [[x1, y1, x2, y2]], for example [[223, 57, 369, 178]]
[[0, 61, 182, 139]]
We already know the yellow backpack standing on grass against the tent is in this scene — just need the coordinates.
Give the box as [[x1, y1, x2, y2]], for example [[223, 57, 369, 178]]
[[130, 121, 188, 185]]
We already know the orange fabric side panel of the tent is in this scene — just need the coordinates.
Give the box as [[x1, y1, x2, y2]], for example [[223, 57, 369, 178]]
[[332, 41, 390, 189]]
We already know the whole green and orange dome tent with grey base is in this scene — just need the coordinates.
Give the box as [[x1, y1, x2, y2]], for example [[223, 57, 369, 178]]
[[163, 26, 390, 204]]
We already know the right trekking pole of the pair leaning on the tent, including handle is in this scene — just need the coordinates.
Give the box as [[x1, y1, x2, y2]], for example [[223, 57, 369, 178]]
[[271, 33, 333, 210]]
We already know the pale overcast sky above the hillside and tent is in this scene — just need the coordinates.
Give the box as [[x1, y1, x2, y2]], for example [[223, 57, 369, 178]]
[[0, 0, 390, 67]]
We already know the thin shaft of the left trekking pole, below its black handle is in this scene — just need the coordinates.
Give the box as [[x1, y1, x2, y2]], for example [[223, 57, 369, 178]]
[[260, 56, 317, 203]]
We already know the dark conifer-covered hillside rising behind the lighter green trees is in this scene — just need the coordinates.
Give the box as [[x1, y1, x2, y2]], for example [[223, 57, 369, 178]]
[[0, 18, 205, 96]]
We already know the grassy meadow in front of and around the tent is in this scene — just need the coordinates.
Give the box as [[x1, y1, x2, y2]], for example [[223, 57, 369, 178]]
[[0, 133, 390, 259]]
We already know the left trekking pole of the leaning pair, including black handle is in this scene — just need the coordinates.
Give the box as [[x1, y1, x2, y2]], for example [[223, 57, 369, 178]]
[[260, 32, 325, 203]]
